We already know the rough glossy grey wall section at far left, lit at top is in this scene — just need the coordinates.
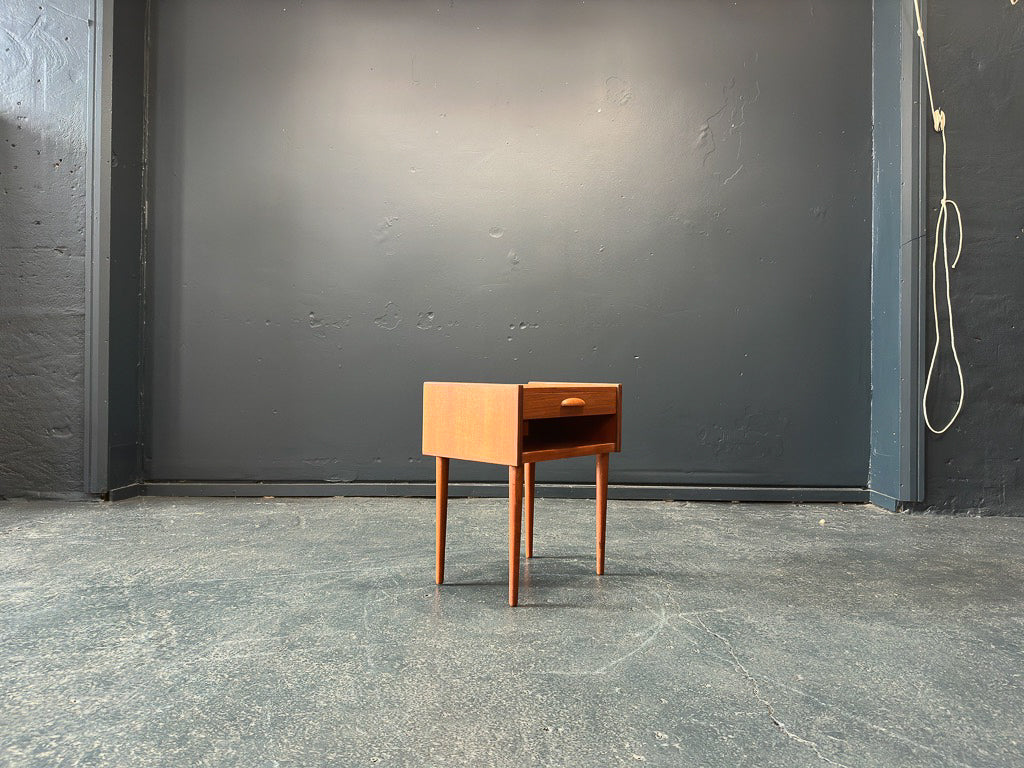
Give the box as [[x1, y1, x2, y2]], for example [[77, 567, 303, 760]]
[[0, 0, 92, 497]]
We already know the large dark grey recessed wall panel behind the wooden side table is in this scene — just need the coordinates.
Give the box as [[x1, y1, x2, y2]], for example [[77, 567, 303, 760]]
[[146, 0, 871, 486]]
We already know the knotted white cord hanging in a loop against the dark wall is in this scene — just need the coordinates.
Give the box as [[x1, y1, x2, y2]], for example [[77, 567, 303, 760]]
[[913, 0, 965, 434]]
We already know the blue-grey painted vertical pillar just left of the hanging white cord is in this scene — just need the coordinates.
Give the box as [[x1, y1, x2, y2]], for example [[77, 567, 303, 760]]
[[867, 0, 927, 509]]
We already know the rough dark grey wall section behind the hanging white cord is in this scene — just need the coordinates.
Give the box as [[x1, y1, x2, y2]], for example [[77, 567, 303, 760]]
[[925, 0, 1024, 515]]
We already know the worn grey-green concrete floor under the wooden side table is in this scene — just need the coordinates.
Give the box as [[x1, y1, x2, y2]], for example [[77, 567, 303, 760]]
[[0, 499, 1024, 768]]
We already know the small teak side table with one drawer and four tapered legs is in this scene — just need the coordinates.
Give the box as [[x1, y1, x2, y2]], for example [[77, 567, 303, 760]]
[[423, 381, 623, 605]]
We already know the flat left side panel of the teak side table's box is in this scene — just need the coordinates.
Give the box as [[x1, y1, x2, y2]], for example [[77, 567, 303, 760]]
[[423, 381, 522, 466]]
